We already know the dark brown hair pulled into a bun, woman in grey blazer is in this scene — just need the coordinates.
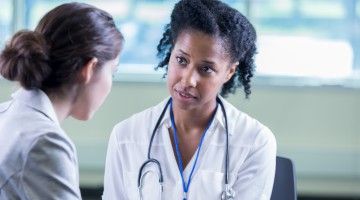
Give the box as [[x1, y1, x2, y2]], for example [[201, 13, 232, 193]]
[[0, 3, 123, 90]]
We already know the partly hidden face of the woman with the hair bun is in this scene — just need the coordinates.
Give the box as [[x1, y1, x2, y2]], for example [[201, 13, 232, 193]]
[[71, 58, 119, 120]]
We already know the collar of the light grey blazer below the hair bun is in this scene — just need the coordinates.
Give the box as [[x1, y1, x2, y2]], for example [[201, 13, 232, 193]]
[[11, 88, 59, 125]]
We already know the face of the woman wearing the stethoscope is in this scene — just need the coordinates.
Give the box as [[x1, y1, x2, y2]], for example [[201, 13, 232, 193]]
[[167, 30, 236, 110]]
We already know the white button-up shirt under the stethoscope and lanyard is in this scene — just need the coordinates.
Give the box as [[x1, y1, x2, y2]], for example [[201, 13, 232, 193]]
[[103, 98, 276, 200]]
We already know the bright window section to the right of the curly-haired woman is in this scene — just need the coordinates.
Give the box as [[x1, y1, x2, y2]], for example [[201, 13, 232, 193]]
[[251, 0, 360, 84]]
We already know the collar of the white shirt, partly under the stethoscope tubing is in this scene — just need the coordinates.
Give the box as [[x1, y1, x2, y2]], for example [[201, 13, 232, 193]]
[[157, 96, 233, 135]]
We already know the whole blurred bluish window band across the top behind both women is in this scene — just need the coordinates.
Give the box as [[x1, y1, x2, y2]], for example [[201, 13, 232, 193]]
[[0, 0, 360, 86]]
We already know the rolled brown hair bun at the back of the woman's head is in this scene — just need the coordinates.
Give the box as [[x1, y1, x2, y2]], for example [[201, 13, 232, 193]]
[[0, 30, 51, 89]]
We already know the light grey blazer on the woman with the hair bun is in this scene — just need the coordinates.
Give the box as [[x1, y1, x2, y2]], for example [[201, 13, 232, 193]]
[[0, 89, 81, 200]]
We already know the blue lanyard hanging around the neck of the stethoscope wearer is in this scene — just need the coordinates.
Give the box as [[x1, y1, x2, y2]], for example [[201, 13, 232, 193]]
[[170, 102, 217, 200]]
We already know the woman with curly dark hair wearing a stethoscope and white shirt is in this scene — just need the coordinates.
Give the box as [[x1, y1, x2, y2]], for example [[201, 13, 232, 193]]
[[103, 0, 276, 200]]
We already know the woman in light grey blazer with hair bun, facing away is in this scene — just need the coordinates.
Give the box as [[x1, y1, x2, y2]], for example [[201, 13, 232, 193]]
[[0, 3, 123, 200]]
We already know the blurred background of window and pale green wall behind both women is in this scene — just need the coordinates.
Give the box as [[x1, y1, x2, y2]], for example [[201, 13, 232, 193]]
[[0, 0, 360, 200]]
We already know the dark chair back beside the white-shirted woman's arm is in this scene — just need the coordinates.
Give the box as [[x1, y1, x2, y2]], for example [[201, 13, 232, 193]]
[[271, 156, 297, 200]]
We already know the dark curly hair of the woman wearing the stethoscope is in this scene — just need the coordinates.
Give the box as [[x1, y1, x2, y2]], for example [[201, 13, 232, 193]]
[[155, 0, 256, 98]]
